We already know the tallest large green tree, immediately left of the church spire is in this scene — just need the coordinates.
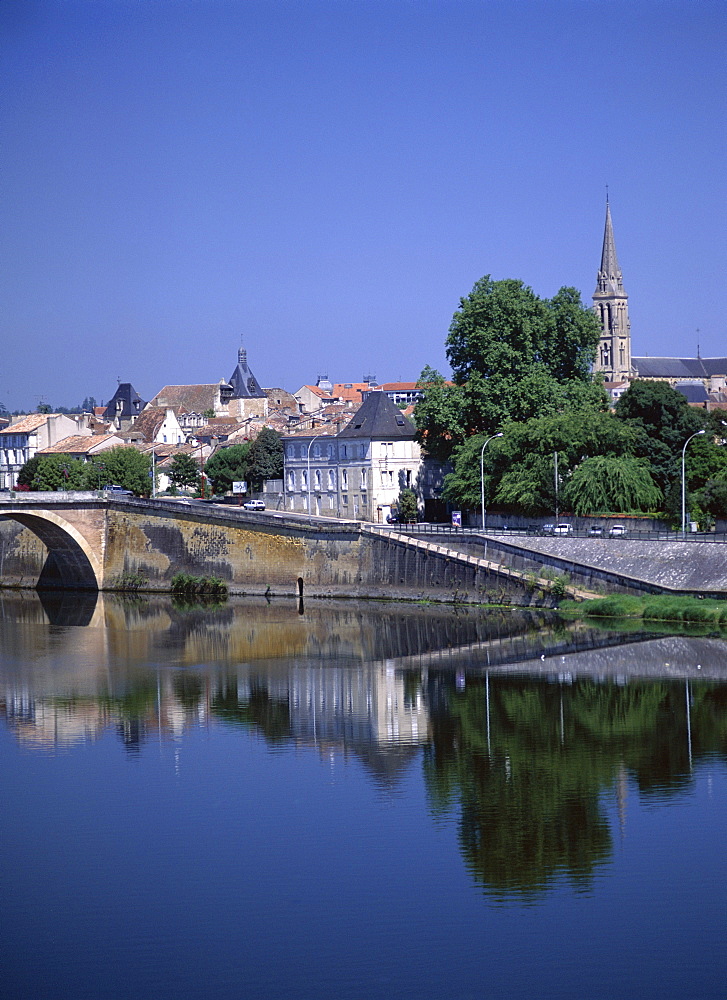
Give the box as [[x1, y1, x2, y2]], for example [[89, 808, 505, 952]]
[[415, 275, 607, 458]]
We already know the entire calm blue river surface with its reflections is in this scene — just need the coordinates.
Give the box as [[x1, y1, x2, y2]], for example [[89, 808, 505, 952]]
[[0, 593, 727, 1000]]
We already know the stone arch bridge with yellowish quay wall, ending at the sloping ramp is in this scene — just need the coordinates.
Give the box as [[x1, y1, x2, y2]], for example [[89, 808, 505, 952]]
[[0, 493, 581, 606]]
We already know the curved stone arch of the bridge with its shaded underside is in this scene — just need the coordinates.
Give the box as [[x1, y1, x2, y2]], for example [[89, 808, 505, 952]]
[[0, 509, 103, 590]]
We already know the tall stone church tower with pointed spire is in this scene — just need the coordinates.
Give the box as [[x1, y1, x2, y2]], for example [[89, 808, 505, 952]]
[[593, 197, 633, 382]]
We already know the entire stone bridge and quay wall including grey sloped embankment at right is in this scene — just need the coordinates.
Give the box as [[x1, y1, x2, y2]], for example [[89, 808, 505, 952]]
[[0, 493, 727, 606]]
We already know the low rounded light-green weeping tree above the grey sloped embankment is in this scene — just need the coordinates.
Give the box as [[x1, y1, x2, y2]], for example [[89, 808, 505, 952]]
[[563, 455, 664, 517]]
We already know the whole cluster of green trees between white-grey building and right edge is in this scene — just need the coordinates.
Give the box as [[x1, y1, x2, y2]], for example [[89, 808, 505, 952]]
[[414, 275, 727, 528]]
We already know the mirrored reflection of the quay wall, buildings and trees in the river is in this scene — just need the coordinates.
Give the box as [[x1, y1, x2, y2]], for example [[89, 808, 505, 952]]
[[0, 594, 727, 900]]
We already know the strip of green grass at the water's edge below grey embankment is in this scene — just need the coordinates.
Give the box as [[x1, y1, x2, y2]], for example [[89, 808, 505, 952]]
[[559, 594, 727, 628]]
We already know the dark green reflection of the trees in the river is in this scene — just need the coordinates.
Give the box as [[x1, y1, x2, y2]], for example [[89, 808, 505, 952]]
[[424, 677, 727, 899]]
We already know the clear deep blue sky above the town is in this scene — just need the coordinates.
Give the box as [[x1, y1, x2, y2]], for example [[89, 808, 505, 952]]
[[0, 0, 727, 409]]
